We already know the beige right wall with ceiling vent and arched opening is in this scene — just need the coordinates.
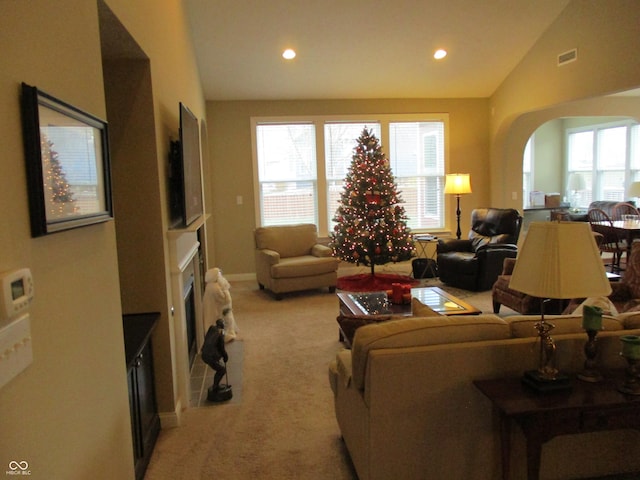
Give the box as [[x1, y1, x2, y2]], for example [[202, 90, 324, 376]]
[[490, 0, 640, 208]]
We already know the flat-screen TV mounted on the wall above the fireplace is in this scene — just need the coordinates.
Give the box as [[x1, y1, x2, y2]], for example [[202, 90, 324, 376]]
[[169, 103, 204, 228]]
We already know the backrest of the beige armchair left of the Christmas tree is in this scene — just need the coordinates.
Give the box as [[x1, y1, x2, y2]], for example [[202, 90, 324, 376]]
[[255, 223, 318, 258]]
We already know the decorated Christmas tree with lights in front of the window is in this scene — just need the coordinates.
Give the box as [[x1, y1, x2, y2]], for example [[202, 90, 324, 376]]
[[331, 128, 414, 275]]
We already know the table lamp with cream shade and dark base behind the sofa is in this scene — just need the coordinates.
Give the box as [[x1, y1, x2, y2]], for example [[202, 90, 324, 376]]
[[509, 222, 611, 392]]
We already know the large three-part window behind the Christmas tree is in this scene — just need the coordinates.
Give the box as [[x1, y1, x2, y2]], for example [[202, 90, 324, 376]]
[[252, 114, 448, 235]]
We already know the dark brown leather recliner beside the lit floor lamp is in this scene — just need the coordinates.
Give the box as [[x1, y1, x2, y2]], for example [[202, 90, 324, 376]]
[[437, 208, 522, 291]]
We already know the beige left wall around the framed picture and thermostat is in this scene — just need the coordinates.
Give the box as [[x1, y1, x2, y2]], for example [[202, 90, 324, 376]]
[[0, 0, 204, 480]]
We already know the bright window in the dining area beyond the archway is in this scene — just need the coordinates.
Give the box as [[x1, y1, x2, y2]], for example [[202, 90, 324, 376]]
[[567, 122, 640, 207]]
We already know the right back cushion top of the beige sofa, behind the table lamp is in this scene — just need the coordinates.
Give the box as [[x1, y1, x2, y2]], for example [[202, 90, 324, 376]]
[[504, 315, 624, 338]]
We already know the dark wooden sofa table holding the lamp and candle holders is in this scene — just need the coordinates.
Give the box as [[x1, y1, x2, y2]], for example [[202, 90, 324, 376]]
[[473, 371, 640, 480]]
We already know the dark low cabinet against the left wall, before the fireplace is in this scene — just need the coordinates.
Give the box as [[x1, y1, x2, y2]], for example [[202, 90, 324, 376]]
[[122, 313, 160, 480]]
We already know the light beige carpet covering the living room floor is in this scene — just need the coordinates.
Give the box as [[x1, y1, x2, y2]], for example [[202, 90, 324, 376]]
[[145, 269, 512, 480]]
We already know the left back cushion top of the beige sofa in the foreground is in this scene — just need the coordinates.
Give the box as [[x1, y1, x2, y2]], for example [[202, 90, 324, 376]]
[[351, 314, 510, 389]]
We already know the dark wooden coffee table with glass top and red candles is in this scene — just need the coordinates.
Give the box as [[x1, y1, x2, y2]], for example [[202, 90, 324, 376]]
[[337, 287, 482, 347]]
